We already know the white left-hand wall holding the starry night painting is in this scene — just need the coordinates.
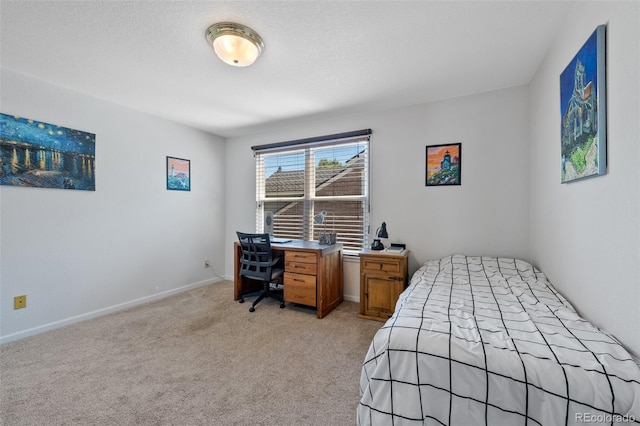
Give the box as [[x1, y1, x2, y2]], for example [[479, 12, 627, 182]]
[[0, 69, 225, 342]]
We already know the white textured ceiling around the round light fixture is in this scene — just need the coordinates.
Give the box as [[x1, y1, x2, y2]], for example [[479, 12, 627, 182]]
[[0, 0, 576, 137]]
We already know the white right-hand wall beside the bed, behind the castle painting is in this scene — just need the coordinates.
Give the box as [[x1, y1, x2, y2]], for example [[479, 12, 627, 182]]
[[529, 1, 640, 355]]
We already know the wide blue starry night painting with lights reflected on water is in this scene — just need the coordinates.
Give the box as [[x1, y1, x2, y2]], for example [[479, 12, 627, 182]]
[[0, 114, 96, 191]]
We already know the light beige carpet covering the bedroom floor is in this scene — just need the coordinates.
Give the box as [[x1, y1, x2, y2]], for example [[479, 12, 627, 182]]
[[0, 281, 382, 426]]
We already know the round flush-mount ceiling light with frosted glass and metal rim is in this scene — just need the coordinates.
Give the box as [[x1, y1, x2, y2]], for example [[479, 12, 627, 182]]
[[206, 22, 264, 67]]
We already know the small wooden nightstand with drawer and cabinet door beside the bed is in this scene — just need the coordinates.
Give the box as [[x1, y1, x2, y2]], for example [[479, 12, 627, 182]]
[[358, 250, 409, 321]]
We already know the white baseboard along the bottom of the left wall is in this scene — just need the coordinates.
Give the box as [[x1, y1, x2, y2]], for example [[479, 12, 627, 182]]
[[0, 278, 222, 345]]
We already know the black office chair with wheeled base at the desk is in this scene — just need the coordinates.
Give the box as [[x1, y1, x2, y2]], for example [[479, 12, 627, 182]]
[[236, 232, 284, 312]]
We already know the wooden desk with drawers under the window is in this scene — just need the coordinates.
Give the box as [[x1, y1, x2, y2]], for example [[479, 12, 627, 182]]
[[233, 240, 344, 318]]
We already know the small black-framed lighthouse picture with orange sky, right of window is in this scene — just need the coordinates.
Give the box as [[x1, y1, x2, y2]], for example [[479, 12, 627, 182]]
[[426, 143, 462, 186]]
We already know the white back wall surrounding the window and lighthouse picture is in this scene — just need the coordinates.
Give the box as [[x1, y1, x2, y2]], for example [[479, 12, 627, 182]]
[[225, 87, 529, 301]]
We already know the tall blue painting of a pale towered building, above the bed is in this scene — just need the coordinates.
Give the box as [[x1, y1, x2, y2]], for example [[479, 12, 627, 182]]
[[560, 25, 607, 183]]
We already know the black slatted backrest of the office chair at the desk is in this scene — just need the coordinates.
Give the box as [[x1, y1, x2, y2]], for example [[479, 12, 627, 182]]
[[236, 232, 273, 281]]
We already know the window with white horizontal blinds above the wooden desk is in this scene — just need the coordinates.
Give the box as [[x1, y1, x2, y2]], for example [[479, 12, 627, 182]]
[[253, 129, 371, 254]]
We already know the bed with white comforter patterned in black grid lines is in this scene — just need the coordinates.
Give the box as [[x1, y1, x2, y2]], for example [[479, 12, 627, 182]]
[[357, 255, 640, 426]]
